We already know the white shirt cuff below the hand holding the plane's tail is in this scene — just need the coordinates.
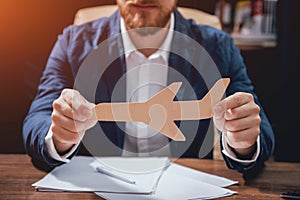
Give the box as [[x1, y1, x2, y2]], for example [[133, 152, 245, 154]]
[[222, 134, 260, 165]]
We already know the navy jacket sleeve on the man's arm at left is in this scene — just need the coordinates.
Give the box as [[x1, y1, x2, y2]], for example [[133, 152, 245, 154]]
[[22, 27, 73, 171]]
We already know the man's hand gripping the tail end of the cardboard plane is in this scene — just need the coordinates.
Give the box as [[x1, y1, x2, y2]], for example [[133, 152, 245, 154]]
[[213, 92, 261, 157]]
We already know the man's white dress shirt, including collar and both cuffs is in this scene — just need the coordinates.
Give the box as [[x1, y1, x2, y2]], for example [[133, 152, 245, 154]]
[[45, 14, 260, 162]]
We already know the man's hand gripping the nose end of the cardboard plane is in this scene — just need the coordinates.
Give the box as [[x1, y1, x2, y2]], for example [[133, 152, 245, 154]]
[[50, 89, 97, 154]]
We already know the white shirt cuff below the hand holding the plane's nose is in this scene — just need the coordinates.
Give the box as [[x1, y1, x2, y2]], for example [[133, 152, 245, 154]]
[[45, 130, 79, 163]]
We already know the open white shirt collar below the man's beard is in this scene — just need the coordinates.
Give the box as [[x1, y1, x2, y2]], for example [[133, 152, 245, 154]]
[[120, 13, 175, 62]]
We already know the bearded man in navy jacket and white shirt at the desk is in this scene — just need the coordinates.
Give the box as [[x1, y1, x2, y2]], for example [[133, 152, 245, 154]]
[[23, 0, 274, 173]]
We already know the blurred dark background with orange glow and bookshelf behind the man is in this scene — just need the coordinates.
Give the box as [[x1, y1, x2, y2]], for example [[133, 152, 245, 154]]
[[0, 0, 300, 162]]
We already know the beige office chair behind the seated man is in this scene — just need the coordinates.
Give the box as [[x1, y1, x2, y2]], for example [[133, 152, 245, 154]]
[[74, 5, 222, 160]]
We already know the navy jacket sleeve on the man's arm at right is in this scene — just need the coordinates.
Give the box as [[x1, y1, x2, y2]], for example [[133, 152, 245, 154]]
[[219, 34, 275, 176]]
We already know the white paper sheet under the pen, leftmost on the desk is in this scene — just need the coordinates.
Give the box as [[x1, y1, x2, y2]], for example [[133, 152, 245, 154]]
[[32, 156, 168, 194]]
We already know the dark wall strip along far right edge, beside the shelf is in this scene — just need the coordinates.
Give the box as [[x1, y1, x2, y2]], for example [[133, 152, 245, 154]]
[[274, 0, 300, 162]]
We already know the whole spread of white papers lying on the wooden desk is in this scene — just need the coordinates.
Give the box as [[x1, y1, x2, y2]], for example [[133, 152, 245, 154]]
[[33, 156, 237, 200]]
